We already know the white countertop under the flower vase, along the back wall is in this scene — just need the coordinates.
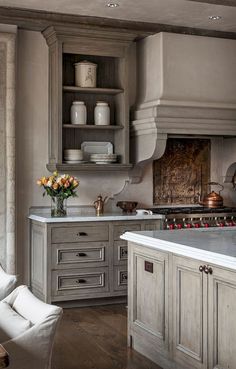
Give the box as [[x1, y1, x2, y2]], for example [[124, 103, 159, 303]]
[[28, 213, 164, 223]]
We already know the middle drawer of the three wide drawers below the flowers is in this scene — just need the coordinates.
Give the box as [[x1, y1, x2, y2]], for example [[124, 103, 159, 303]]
[[52, 242, 108, 269]]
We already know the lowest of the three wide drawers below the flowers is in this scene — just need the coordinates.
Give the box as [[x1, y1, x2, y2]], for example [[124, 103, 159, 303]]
[[52, 267, 109, 298]]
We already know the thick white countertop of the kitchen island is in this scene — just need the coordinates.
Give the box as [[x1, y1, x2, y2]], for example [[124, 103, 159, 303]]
[[121, 227, 236, 270]]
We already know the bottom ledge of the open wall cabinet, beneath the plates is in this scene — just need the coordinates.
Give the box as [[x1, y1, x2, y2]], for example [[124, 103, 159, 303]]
[[47, 163, 133, 172]]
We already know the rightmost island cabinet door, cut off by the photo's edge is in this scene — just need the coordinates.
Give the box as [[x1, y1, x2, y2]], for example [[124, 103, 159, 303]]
[[208, 267, 236, 369]]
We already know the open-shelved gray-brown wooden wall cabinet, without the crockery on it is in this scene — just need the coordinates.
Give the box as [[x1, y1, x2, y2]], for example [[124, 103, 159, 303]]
[[43, 26, 135, 171]]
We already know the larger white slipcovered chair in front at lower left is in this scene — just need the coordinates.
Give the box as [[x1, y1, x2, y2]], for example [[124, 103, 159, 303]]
[[0, 286, 62, 369]]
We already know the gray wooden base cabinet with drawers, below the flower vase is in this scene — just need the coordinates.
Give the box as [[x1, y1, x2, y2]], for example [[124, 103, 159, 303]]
[[30, 220, 160, 305]]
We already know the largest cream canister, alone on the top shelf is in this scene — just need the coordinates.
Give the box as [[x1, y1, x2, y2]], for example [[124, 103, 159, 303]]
[[74, 60, 97, 87]]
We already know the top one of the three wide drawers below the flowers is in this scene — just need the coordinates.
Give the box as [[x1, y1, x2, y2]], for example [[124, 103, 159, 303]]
[[52, 225, 109, 243]]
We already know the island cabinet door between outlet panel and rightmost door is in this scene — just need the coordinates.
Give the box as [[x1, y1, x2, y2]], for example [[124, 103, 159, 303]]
[[173, 256, 207, 369]]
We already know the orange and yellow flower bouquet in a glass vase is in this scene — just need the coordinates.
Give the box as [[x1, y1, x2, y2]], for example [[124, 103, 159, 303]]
[[37, 172, 79, 217]]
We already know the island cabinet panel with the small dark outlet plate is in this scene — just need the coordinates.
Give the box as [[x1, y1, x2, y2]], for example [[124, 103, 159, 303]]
[[128, 244, 168, 355]]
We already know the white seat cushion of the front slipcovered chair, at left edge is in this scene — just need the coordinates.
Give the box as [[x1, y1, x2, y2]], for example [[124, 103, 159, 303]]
[[0, 301, 31, 343]]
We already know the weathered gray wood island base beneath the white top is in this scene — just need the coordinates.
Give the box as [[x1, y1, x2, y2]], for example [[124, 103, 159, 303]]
[[128, 243, 236, 369]]
